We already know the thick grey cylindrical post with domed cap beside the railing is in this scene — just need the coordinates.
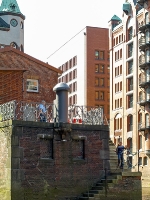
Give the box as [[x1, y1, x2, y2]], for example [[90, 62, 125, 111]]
[[53, 83, 70, 123]]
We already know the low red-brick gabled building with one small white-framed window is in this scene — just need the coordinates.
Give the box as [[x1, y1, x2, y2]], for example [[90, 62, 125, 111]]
[[0, 47, 61, 104]]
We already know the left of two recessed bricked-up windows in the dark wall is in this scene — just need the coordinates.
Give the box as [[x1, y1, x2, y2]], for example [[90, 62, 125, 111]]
[[40, 138, 53, 159]]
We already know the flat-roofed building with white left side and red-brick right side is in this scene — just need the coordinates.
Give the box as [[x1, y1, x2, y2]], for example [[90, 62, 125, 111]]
[[49, 26, 110, 123]]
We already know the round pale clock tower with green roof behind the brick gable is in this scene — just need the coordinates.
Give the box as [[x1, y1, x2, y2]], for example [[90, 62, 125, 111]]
[[0, 0, 25, 51]]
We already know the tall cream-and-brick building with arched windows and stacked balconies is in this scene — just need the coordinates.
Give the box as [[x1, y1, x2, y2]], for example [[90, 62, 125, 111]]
[[109, 0, 150, 184]]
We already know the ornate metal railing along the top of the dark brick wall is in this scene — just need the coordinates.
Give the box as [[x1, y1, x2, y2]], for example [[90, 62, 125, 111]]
[[0, 100, 103, 125]]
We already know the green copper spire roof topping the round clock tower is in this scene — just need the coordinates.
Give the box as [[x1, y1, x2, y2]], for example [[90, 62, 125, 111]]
[[0, 0, 22, 14]]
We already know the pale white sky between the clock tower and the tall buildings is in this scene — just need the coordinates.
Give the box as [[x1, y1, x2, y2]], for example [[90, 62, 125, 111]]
[[0, 0, 125, 63]]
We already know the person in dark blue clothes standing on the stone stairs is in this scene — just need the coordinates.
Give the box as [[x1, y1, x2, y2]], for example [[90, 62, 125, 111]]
[[116, 142, 127, 169]]
